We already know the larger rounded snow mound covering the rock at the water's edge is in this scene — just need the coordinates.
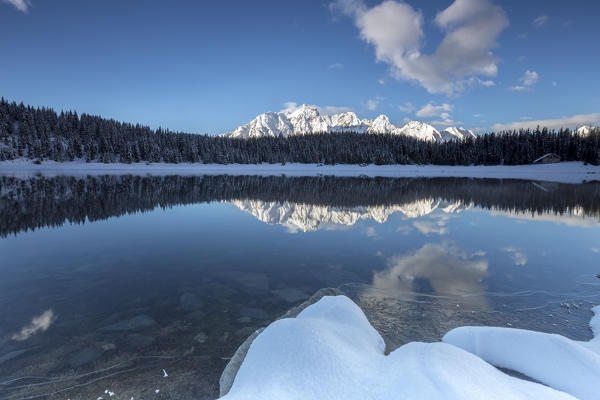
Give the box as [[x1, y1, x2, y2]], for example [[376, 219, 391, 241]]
[[224, 296, 574, 400]]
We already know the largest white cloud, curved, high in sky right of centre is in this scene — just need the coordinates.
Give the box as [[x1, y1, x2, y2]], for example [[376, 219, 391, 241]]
[[330, 0, 508, 95]]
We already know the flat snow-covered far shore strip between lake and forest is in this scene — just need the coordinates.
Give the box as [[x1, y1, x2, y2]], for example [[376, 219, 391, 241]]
[[0, 160, 600, 183]]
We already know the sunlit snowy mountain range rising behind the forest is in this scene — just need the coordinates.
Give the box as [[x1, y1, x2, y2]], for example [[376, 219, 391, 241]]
[[225, 104, 476, 142]]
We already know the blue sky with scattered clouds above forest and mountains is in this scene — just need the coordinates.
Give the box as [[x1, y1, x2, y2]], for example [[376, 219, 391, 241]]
[[0, 0, 600, 134]]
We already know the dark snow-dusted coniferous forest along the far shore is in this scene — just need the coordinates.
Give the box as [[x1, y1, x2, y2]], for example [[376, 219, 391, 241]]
[[0, 99, 600, 165]]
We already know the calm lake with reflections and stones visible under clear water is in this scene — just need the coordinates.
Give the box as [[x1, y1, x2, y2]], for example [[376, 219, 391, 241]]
[[0, 175, 600, 399]]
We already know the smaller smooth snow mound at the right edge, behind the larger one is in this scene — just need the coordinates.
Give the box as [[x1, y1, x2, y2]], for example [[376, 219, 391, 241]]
[[442, 306, 600, 400]]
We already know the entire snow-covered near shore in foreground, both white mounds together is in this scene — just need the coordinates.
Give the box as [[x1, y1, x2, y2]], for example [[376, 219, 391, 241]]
[[223, 296, 600, 400]]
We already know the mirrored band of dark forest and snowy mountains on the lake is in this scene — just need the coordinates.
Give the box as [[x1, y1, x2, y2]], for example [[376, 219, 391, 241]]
[[0, 175, 600, 236]]
